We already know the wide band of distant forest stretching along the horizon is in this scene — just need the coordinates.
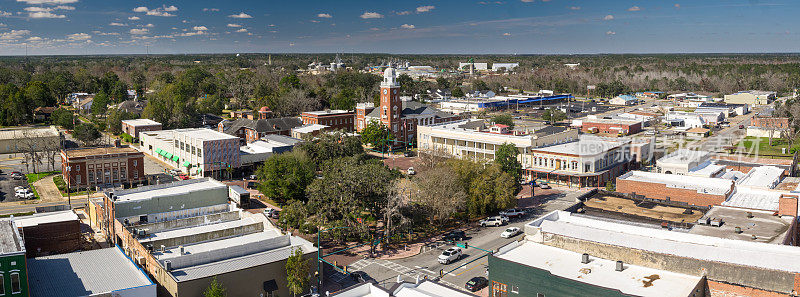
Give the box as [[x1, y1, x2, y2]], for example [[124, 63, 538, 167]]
[[0, 54, 800, 127]]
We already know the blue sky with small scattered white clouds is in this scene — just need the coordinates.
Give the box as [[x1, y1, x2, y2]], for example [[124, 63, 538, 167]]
[[0, 0, 800, 56]]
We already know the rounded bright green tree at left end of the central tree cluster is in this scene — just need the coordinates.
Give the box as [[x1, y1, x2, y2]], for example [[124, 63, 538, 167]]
[[256, 151, 315, 205]]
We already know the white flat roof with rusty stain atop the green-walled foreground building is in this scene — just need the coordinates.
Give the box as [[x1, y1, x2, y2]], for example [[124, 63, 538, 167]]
[[495, 240, 701, 297]]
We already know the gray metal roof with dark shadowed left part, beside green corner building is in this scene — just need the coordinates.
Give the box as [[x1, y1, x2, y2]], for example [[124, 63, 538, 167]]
[[28, 248, 155, 297]]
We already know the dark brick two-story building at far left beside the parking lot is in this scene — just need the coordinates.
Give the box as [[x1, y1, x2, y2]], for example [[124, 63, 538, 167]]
[[61, 147, 145, 188]]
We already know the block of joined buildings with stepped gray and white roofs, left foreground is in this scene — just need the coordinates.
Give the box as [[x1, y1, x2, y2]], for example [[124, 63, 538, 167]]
[[90, 178, 317, 297]]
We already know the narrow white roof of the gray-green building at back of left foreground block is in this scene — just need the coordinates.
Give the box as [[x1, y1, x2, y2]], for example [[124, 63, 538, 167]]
[[113, 178, 227, 202]]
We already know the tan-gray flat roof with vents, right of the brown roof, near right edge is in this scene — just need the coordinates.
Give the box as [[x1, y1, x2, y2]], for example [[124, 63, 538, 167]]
[[689, 206, 792, 244]]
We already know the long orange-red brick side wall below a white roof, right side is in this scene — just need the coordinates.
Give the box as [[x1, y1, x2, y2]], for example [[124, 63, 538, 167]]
[[617, 178, 733, 206]]
